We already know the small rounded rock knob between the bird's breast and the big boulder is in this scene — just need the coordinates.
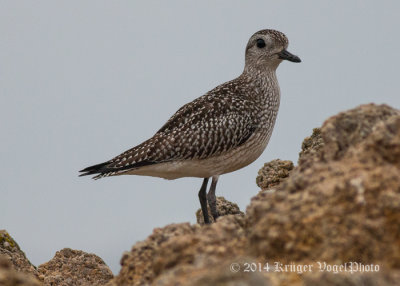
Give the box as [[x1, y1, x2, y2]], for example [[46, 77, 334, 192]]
[[256, 159, 294, 190]]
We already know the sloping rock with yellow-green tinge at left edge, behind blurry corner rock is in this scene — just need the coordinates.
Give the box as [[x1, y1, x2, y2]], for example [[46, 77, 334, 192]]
[[0, 230, 38, 276]]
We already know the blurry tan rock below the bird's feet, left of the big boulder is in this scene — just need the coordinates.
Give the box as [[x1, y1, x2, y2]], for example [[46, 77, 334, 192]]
[[110, 215, 245, 285]]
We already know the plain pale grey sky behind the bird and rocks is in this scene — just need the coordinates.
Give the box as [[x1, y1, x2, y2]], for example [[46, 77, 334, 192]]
[[0, 0, 400, 272]]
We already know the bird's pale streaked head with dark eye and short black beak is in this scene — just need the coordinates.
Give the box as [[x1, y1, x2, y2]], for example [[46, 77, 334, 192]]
[[245, 30, 301, 71]]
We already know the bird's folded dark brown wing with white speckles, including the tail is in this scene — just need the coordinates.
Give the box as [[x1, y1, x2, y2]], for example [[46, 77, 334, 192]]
[[82, 94, 257, 178]]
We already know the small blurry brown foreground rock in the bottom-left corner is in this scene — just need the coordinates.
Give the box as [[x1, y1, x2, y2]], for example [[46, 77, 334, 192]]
[[0, 255, 42, 286]]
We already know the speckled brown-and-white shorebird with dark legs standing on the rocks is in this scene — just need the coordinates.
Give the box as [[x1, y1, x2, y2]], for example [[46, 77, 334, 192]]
[[79, 29, 301, 224]]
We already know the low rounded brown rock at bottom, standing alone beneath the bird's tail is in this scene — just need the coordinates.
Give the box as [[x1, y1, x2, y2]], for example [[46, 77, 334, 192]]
[[38, 248, 113, 286]]
